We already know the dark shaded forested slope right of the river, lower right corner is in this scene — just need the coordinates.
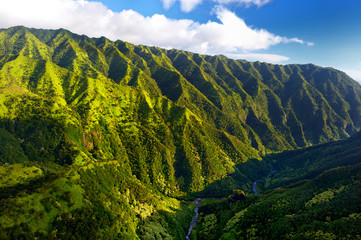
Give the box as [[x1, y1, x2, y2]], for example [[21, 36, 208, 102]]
[[194, 133, 361, 240]]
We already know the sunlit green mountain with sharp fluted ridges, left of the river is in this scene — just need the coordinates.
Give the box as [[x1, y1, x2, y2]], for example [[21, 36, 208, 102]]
[[0, 27, 361, 239]]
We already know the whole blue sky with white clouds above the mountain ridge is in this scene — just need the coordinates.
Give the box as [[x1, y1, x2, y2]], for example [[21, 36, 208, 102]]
[[0, 0, 361, 81]]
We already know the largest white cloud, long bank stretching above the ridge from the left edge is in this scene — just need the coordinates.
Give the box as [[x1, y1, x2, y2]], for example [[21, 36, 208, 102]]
[[0, 0, 310, 62]]
